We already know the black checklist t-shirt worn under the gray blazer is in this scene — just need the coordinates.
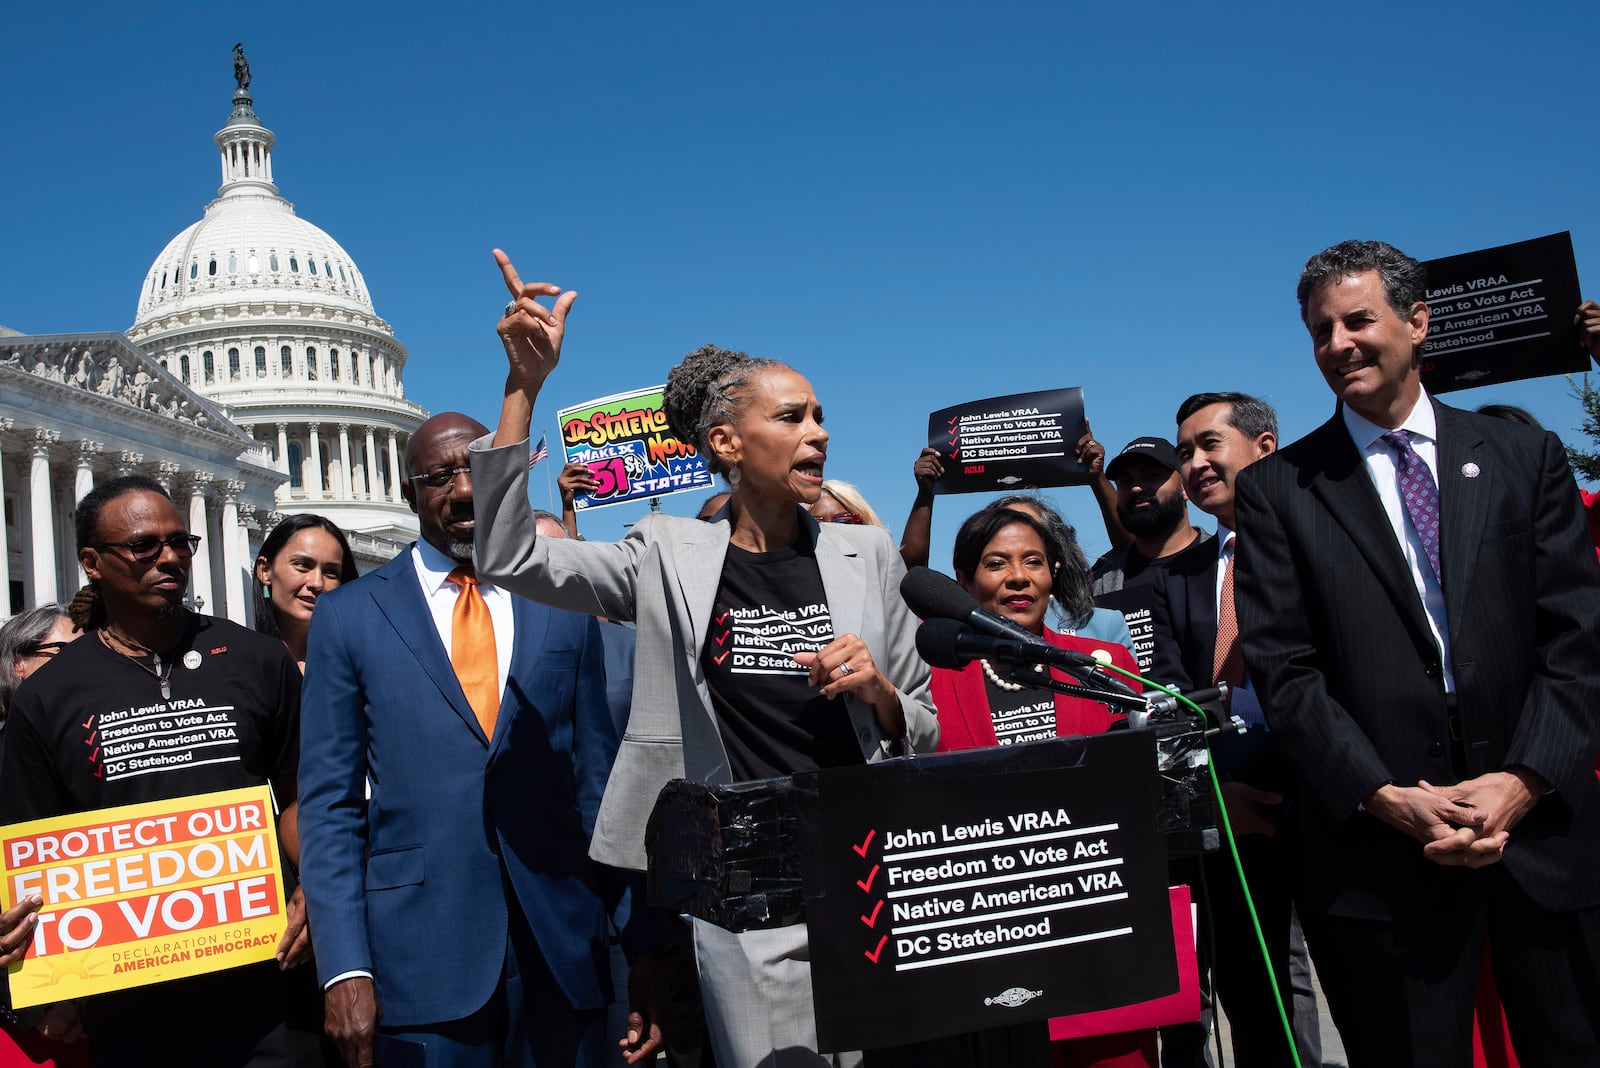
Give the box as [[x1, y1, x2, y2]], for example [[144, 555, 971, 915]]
[[701, 545, 864, 782]]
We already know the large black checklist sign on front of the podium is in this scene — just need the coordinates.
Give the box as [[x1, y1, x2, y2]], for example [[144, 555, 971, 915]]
[[800, 731, 1178, 1050]]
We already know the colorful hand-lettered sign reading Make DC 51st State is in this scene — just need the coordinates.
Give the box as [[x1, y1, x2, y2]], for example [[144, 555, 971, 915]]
[[557, 385, 712, 510]]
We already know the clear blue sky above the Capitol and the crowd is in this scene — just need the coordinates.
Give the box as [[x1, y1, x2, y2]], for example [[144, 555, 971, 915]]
[[0, 0, 1600, 566]]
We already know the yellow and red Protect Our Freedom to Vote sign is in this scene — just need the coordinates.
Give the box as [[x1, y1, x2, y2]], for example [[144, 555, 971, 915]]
[[0, 787, 288, 1007]]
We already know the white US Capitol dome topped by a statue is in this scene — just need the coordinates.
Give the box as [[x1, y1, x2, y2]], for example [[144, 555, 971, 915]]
[[126, 62, 427, 559]]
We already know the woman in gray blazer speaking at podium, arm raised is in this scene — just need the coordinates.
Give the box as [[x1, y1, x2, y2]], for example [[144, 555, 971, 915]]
[[472, 249, 938, 1068]]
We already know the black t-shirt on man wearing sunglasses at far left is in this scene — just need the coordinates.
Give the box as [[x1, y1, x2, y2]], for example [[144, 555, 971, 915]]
[[0, 616, 301, 1065]]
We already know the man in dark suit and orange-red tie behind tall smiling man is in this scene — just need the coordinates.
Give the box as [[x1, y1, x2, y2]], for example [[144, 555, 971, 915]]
[[1150, 392, 1322, 1068]]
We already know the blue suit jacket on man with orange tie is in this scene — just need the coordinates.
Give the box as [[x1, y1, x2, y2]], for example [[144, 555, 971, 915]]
[[299, 552, 622, 1026]]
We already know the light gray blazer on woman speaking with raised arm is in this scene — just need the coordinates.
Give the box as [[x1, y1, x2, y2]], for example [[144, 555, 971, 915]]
[[472, 435, 939, 870]]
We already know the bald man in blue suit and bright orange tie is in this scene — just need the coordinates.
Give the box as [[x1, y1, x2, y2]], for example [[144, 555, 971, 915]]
[[299, 412, 636, 1068]]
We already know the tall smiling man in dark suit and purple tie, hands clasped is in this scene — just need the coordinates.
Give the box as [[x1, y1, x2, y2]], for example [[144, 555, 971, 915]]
[[1235, 241, 1600, 1068]]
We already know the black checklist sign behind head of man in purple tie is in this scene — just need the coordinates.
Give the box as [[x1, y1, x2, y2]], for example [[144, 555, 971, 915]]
[[1422, 232, 1589, 393]]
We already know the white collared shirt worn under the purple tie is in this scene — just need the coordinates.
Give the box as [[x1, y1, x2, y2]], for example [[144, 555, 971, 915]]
[[1344, 390, 1456, 694]]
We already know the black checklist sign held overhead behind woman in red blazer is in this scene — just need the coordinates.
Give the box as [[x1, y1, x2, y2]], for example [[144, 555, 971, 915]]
[[928, 387, 1088, 494]]
